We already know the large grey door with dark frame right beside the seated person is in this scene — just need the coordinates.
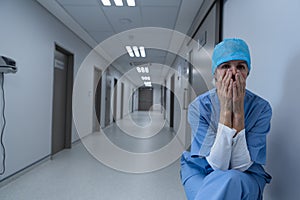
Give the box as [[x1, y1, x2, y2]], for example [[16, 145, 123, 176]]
[[185, 1, 222, 148]]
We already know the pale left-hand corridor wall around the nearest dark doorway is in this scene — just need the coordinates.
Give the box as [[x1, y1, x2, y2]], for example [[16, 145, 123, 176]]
[[0, 0, 112, 180]]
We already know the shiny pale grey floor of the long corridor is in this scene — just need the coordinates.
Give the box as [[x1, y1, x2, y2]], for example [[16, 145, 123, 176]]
[[0, 112, 186, 200]]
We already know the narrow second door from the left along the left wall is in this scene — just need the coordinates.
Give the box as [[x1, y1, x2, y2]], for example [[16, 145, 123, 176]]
[[93, 67, 102, 132]]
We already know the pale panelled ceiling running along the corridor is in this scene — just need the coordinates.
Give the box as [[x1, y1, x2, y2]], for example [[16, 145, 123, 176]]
[[37, 0, 204, 85]]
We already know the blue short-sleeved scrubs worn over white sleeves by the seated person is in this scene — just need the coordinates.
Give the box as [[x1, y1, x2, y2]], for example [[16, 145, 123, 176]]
[[181, 89, 272, 200]]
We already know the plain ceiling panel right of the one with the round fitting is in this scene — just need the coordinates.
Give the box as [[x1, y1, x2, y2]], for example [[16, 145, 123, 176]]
[[142, 6, 178, 29]]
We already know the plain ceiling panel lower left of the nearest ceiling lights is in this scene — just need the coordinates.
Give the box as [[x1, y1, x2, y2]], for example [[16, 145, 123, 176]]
[[64, 6, 112, 31]]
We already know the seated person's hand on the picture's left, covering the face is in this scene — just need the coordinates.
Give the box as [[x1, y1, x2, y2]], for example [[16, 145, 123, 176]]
[[216, 70, 233, 127]]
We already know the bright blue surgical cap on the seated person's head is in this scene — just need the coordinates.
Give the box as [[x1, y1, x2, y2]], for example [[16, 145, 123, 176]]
[[212, 38, 251, 74]]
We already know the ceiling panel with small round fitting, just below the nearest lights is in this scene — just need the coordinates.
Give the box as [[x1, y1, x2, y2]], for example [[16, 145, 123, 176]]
[[103, 7, 142, 33]]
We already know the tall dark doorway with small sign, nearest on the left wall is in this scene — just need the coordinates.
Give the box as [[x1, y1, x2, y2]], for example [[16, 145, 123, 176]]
[[51, 44, 74, 155]]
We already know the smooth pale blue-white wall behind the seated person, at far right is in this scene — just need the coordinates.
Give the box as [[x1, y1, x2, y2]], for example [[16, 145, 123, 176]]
[[223, 0, 300, 200]]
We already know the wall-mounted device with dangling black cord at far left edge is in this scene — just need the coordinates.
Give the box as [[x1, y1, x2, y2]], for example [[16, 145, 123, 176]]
[[0, 56, 17, 175]]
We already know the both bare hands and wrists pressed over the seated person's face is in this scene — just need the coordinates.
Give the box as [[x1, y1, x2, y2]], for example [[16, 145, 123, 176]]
[[216, 69, 246, 134]]
